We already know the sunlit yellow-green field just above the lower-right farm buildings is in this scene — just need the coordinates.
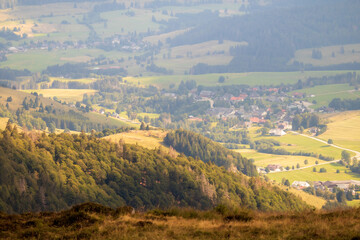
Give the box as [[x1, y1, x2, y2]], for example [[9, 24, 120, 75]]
[[267, 163, 360, 183]]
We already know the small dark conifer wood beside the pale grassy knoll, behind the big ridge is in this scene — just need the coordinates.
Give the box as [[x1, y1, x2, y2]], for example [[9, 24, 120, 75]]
[[164, 129, 257, 176]]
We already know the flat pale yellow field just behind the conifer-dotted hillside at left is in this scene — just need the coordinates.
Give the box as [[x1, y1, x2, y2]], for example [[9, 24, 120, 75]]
[[23, 89, 97, 102]]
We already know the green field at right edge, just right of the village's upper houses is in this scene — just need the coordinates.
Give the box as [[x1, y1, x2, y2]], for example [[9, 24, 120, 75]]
[[294, 84, 360, 109]]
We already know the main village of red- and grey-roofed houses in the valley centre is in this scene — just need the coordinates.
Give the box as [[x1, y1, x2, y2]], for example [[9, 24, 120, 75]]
[[174, 88, 313, 127]]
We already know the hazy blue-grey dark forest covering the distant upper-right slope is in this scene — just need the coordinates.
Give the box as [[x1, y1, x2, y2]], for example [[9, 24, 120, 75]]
[[169, 0, 360, 74]]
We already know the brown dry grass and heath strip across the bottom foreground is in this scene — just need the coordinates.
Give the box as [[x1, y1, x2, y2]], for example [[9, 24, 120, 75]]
[[0, 203, 360, 240]]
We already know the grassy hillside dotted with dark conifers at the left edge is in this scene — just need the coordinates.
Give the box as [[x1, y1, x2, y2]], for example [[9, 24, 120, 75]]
[[0, 87, 127, 132]]
